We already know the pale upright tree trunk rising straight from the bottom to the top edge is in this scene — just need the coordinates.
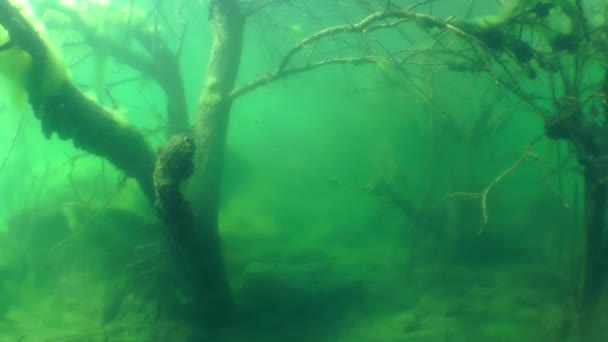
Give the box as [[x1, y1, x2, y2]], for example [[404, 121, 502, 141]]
[[183, 0, 244, 324]]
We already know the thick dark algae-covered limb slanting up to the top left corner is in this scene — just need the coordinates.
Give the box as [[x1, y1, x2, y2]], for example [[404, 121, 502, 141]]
[[0, 0, 156, 202]]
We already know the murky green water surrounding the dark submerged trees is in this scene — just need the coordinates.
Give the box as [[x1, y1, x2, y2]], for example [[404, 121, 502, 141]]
[[0, 0, 608, 342]]
